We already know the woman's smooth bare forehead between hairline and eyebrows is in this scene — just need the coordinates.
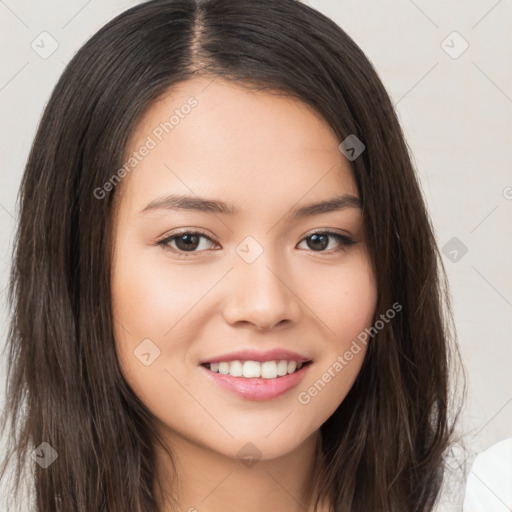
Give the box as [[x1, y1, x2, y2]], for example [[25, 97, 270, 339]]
[[117, 78, 357, 214]]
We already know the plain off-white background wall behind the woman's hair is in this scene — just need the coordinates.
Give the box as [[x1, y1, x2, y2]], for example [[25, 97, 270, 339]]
[[0, 0, 512, 510]]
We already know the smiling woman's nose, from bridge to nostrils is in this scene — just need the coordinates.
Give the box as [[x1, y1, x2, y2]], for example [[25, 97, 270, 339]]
[[223, 250, 300, 330]]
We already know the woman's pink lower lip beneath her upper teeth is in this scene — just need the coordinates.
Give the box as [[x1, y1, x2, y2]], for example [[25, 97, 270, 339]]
[[200, 363, 311, 400]]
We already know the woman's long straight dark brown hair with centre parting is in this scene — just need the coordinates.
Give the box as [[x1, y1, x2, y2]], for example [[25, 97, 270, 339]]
[[1, 0, 464, 512]]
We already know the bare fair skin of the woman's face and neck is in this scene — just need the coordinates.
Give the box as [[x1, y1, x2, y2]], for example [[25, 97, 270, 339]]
[[112, 78, 377, 512]]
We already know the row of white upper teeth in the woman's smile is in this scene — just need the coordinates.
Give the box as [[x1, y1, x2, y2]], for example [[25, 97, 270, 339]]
[[204, 360, 304, 379]]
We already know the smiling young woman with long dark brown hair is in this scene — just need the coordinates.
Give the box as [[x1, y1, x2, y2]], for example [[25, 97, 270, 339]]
[[0, 0, 464, 512]]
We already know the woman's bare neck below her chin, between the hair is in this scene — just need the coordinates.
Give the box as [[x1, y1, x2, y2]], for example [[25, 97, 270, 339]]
[[157, 431, 321, 512]]
